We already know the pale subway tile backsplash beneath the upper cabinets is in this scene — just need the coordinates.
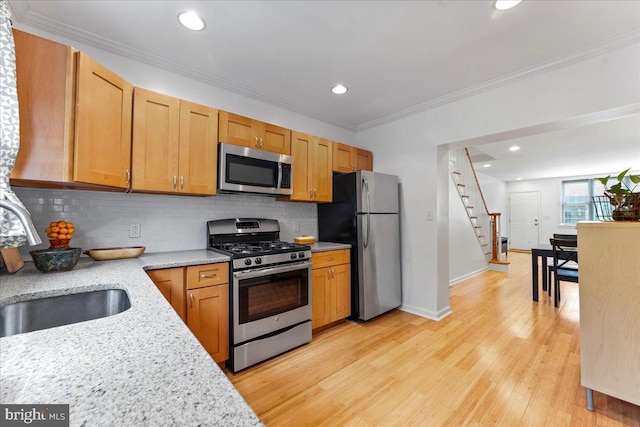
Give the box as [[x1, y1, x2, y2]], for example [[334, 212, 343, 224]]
[[13, 187, 318, 259]]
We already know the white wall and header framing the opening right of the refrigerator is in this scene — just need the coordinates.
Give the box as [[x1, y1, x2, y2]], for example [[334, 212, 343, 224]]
[[357, 44, 640, 318]]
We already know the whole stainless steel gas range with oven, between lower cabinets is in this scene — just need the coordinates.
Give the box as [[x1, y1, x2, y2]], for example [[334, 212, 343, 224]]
[[207, 218, 311, 372]]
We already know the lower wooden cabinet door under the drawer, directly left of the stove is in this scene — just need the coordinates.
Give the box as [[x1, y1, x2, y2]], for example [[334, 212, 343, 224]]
[[187, 284, 229, 363]]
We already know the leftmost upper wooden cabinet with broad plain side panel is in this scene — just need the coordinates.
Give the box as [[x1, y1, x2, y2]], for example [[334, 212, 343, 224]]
[[11, 30, 133, 189]]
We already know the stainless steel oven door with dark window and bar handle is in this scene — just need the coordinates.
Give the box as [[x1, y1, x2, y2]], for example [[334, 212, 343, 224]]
[[232, 261, 311, 345]]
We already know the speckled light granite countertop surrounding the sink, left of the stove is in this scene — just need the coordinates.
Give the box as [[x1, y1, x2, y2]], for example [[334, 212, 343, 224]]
[[0, 250, 262, 426]]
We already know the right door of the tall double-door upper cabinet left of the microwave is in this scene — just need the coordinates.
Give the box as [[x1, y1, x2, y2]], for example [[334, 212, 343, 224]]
[[178, 101, 218, 195]]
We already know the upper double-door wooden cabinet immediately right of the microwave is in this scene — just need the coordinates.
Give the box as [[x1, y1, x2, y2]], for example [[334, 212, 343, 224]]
[[289, 131, 333, 202]]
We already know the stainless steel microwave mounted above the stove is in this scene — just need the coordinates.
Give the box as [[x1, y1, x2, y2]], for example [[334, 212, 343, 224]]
[[218, 143, 293, 195]]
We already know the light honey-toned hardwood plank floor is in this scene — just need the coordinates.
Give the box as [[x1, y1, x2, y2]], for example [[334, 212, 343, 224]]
[[227, 253, 640, 427]]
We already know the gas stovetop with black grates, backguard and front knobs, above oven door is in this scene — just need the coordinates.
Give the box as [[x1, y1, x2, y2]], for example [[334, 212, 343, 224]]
[[207, 218, 311, 270]]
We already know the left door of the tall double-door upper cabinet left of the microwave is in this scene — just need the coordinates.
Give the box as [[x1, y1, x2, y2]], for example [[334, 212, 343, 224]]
[[131, 88, 180, 193]]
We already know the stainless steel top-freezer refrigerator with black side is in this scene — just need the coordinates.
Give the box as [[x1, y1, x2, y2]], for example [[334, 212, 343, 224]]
[[318, 171, 402, 321]]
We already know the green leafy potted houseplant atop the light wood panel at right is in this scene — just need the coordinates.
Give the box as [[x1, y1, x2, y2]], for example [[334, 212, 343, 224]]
[[597, 168, 640, 221]]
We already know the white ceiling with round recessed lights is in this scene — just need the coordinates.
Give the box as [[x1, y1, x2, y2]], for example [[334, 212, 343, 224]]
[[9, 0, 640, 180]]
